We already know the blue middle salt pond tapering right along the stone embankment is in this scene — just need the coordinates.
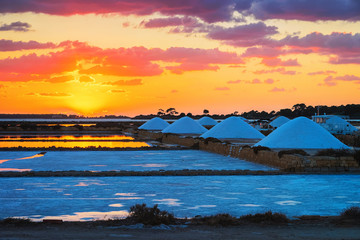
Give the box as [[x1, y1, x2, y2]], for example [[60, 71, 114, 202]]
[[0, 150, 273, 171]]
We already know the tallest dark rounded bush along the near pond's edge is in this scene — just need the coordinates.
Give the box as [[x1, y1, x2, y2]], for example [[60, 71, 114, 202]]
[[128, 203, 175, 225]]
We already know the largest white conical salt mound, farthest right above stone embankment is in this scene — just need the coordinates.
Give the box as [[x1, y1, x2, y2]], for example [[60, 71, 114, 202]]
[[254, 117, 349, 149]]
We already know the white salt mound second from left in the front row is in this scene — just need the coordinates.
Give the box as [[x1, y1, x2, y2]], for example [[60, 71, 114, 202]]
[[162, 117, 207, 134]]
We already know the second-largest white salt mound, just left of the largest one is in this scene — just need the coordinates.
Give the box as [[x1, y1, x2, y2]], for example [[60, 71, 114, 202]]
[[200, 117, 265, 139]]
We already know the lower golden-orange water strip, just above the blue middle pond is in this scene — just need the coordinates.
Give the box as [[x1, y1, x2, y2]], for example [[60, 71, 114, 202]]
[[0, 141, 150, 148]]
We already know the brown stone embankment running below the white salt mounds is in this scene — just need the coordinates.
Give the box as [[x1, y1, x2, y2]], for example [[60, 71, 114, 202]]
[[138, 131, 360, 173]]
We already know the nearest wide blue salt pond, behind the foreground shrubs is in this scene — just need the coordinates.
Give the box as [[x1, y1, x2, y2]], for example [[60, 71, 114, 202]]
[[0, 175, 360, 220]]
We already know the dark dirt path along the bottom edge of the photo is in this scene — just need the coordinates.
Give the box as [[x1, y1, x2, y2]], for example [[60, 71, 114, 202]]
[[0, 223, 360, 240]]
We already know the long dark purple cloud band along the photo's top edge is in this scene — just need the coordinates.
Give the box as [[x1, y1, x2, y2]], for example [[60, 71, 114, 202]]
[[0, 0, 360, 22]]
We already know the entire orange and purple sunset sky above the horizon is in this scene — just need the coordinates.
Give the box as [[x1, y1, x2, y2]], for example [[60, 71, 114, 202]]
[[0, 0, 360, 116]]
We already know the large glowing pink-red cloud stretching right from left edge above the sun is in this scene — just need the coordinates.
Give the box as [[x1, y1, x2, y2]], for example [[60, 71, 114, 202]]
[[0, 41, 243, 81]]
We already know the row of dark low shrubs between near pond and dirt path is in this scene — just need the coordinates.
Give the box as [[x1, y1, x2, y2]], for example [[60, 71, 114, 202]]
[[0, 203, 360, 227]]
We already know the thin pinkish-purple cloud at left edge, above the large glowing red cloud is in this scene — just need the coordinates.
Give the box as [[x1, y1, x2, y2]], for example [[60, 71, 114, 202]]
[[0, 39, 56, 52]]
